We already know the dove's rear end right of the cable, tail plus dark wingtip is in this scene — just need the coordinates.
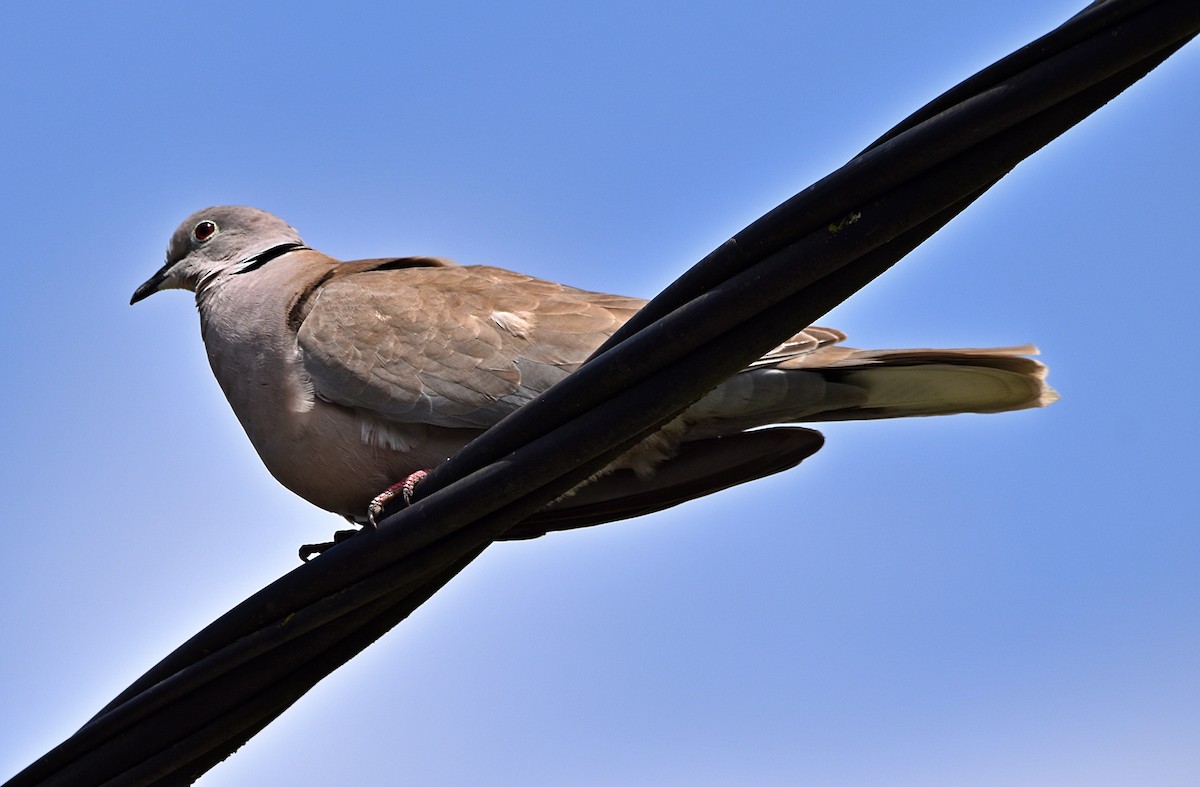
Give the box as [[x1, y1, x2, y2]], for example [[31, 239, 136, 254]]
[[530, 340, 1058, 539]]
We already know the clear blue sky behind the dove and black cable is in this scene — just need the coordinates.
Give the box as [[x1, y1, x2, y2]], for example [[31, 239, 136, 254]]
[[0, 0, 1200, 787]]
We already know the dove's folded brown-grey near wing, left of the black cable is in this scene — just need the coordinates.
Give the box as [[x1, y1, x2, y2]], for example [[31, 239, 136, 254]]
[[298, 266, 643, 428]]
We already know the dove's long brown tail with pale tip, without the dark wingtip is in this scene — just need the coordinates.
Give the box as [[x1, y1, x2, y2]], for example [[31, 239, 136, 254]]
[[686, 344, 1058, 439]]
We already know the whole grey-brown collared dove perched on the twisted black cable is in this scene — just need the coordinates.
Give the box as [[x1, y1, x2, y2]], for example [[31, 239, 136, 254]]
[[130, 202, 1056, 535]]
